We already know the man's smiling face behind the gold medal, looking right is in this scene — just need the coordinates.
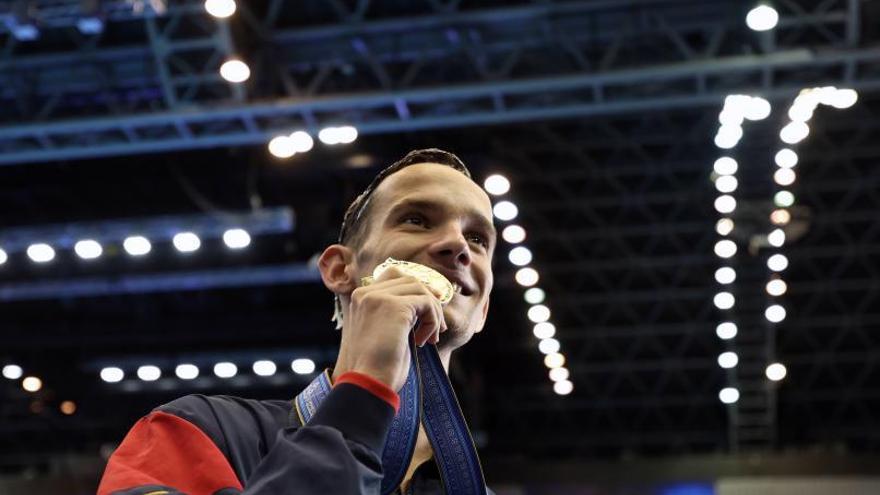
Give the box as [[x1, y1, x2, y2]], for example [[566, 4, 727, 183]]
[[354, 163, 496, 350]]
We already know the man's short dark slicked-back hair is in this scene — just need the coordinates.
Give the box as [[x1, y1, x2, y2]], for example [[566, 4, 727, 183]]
[[333, 148, 473, 328]]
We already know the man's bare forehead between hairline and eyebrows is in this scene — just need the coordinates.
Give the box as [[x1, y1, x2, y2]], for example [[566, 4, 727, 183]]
[[374, 163, 492, 219]]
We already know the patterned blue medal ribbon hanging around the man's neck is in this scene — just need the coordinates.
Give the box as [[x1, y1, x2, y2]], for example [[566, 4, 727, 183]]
[[294, 334, 487, 495]]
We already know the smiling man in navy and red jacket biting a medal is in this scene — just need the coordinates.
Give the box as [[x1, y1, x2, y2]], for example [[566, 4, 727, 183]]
[[98, 149, 496, 495]]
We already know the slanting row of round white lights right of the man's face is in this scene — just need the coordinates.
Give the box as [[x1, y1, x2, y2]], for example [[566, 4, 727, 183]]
[[483, 174, 574, 395]]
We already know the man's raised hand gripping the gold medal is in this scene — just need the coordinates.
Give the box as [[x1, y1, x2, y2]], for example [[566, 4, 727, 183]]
[[334, 267, 447, 391]]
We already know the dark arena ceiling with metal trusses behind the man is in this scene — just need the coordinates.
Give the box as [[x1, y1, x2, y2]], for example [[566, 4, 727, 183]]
[[0, 0, 880, 482]]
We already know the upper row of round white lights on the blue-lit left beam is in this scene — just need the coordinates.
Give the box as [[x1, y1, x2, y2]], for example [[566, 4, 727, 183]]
[[0, 228, 251, 265]]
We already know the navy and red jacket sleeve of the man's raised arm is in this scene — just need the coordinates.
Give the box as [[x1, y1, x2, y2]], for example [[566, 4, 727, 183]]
[[98, 383, 395, 495]]
